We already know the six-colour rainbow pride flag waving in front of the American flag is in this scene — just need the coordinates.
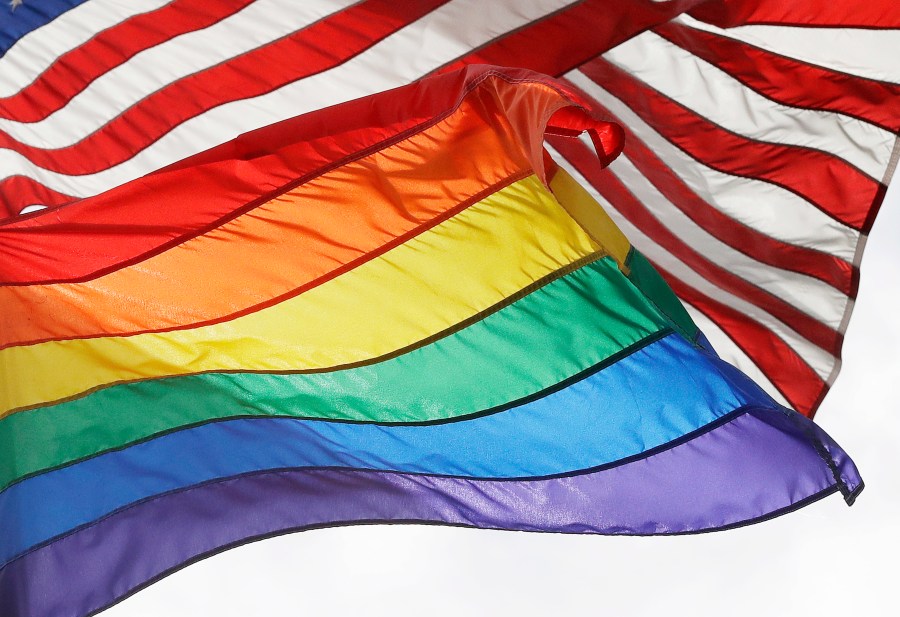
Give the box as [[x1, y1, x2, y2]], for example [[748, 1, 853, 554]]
[[0, 66, 862, 617]]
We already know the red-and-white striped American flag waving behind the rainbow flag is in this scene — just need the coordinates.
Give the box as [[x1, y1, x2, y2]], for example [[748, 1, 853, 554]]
[[0, 0, 900, 415]]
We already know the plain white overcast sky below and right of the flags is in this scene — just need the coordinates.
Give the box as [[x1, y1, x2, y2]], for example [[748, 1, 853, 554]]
[[103, 180, 900, 617]]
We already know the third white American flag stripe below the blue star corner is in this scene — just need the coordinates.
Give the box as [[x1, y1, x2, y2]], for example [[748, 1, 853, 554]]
[[0, 0, 571, 190]]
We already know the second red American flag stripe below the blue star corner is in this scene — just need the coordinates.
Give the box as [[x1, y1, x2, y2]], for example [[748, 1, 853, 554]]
[[0, 0, 446, 175]]
